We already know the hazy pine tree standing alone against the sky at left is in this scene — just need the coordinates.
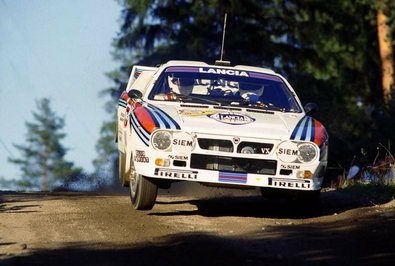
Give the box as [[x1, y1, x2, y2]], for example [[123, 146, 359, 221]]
[[9, 98, 82, 191]]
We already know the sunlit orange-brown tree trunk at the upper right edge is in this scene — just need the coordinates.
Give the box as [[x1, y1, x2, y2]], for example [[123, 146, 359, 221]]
[[377, 9, 394, 104]]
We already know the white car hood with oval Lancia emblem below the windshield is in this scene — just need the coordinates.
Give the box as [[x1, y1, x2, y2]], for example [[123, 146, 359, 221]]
[[161, 103, 304, 139]]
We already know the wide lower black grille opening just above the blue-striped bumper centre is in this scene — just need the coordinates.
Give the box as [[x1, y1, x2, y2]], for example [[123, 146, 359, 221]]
[[191, 154, 277, 175]]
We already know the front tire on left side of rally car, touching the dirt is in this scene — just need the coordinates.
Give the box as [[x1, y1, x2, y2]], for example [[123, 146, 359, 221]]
[[130, 171, 158, 210]]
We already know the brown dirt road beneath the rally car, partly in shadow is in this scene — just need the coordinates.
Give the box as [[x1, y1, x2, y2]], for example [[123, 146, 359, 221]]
[[0, 184, 395, 266]]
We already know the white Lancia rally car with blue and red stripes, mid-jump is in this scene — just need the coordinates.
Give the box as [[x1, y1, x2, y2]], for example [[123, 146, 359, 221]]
[[116, 61, 328, 210]]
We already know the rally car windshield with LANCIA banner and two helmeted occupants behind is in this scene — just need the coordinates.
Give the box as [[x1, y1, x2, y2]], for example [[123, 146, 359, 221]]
[[148, 67, 301, 112]]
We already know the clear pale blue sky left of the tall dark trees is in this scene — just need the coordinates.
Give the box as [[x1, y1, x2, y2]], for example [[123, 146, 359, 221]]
[[0, 0, 122, 183]]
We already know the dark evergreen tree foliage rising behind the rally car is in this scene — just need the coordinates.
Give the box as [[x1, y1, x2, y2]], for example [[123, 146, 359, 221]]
[[96, 0, 395, 182]]
